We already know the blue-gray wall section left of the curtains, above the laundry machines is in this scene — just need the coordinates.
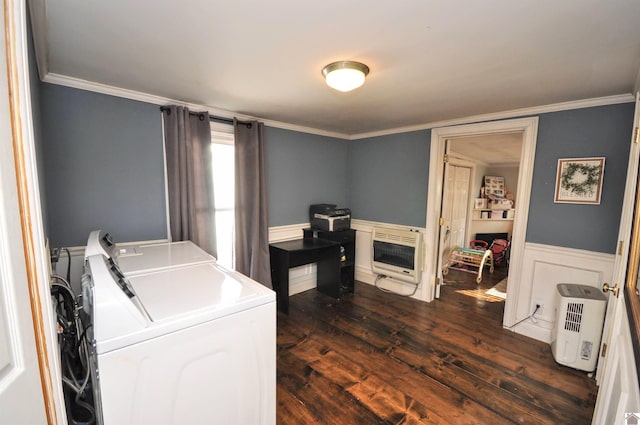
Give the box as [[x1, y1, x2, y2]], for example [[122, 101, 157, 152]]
[[40, 84, 167, 247]]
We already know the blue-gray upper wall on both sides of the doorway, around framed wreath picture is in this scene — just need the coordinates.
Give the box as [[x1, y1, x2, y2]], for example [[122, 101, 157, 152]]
[[348, 103, 634, 253]]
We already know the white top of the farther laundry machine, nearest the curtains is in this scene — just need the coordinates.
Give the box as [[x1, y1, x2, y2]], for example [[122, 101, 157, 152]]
[[117, 241, 216, 275]]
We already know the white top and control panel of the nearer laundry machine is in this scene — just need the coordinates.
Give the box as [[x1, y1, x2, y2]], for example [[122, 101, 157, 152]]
[[90, 256, 275, 354]]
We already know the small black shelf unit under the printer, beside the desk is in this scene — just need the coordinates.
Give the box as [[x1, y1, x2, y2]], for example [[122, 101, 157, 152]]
[[302, 228, 356, 298]]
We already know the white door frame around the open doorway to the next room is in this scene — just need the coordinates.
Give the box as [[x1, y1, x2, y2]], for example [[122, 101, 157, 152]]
[[424, 117, 538, 327]]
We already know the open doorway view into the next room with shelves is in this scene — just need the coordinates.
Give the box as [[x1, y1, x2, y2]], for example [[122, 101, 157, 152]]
[[436, 131, 523, 302]]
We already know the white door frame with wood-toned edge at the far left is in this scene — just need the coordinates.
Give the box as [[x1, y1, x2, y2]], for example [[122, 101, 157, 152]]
[[2, 0, 66, 425]]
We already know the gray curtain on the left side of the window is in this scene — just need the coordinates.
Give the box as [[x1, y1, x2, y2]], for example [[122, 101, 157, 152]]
[[162, 106, 217, 256]]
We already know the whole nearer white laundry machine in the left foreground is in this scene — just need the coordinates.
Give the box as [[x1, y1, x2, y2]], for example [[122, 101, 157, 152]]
[[83, 255, 276, 425]]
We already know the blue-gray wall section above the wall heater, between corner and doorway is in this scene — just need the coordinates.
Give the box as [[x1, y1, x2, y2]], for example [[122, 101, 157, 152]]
[[348, 130, 431, 227]]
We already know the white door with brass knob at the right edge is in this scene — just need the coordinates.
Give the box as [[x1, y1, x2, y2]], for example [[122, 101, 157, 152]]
[[592, 95, 640, 425]]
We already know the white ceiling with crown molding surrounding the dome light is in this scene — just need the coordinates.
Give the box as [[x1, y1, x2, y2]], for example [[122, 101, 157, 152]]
[[30, 0, 640, 138]]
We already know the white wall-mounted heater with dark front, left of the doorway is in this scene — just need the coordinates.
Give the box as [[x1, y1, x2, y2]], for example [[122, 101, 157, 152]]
[[371, 227, 422, 283]]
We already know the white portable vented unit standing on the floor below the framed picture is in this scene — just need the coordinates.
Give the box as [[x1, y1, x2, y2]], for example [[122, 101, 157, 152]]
[[551, 283, 607, 372]]
